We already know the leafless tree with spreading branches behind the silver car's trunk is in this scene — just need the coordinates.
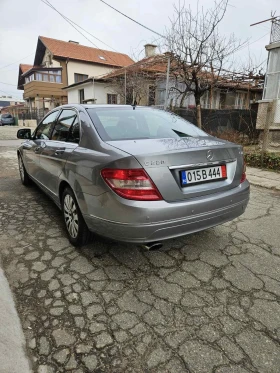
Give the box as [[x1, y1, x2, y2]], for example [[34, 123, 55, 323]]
[[166, 0, 244, 128]]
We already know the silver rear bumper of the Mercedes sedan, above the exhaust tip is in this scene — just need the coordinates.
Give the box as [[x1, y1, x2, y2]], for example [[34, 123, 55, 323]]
[[84, 181, 250, 243]]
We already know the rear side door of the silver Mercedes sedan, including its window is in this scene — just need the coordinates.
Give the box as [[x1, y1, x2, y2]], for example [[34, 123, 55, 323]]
[[40, 109, 79, 196]]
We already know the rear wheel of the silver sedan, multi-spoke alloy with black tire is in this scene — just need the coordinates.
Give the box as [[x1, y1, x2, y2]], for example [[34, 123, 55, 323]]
[[61, 187, 92, 246]]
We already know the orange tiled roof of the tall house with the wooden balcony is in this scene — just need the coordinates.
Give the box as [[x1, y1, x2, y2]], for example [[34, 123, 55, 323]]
[[39, 36, 134, 67]]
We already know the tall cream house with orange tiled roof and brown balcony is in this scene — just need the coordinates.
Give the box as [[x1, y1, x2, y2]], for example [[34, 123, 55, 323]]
[[18, 36, 133, 111]]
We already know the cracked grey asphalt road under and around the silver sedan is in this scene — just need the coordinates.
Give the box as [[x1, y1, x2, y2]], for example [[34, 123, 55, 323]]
[[0, 143, 280, 373]]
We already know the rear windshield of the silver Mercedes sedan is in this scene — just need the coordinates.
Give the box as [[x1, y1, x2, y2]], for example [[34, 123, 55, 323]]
[[87, 107, 207, 141]]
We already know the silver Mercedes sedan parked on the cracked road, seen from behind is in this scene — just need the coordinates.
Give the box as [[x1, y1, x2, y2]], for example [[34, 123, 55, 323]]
[[17, 105, 250, 249]]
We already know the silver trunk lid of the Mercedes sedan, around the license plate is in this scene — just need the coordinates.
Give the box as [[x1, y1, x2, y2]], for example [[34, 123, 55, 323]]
[[107, 136, 243, 202]]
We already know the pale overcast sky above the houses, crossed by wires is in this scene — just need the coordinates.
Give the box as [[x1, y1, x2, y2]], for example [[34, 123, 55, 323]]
[[0, 0, 280, 96]]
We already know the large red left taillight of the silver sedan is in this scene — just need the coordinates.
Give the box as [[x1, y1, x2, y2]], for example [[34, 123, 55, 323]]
[[101, 168, 162, 201]]
